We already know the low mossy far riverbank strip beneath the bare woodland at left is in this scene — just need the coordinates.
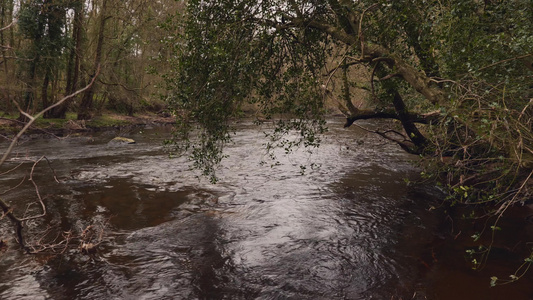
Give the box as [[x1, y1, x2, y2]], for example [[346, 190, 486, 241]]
[[0, 112, 175, 136]]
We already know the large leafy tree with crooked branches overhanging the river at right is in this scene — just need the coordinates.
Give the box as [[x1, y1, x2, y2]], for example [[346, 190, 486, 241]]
[[166, 0, 533, 197]]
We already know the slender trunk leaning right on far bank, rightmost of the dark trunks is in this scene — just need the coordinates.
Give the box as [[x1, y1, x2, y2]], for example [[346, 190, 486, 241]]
[[78, 0, 107, 120]]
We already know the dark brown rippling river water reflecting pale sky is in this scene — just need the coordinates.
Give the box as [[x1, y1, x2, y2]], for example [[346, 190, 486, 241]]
[[0, 121, 533, 299]]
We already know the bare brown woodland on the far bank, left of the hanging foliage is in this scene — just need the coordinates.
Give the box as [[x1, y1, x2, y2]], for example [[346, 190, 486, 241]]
[[0, 0, 183, 121]]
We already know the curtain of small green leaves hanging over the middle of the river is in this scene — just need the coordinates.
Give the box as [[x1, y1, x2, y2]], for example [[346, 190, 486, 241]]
[[165, 1, 327, 179]]
